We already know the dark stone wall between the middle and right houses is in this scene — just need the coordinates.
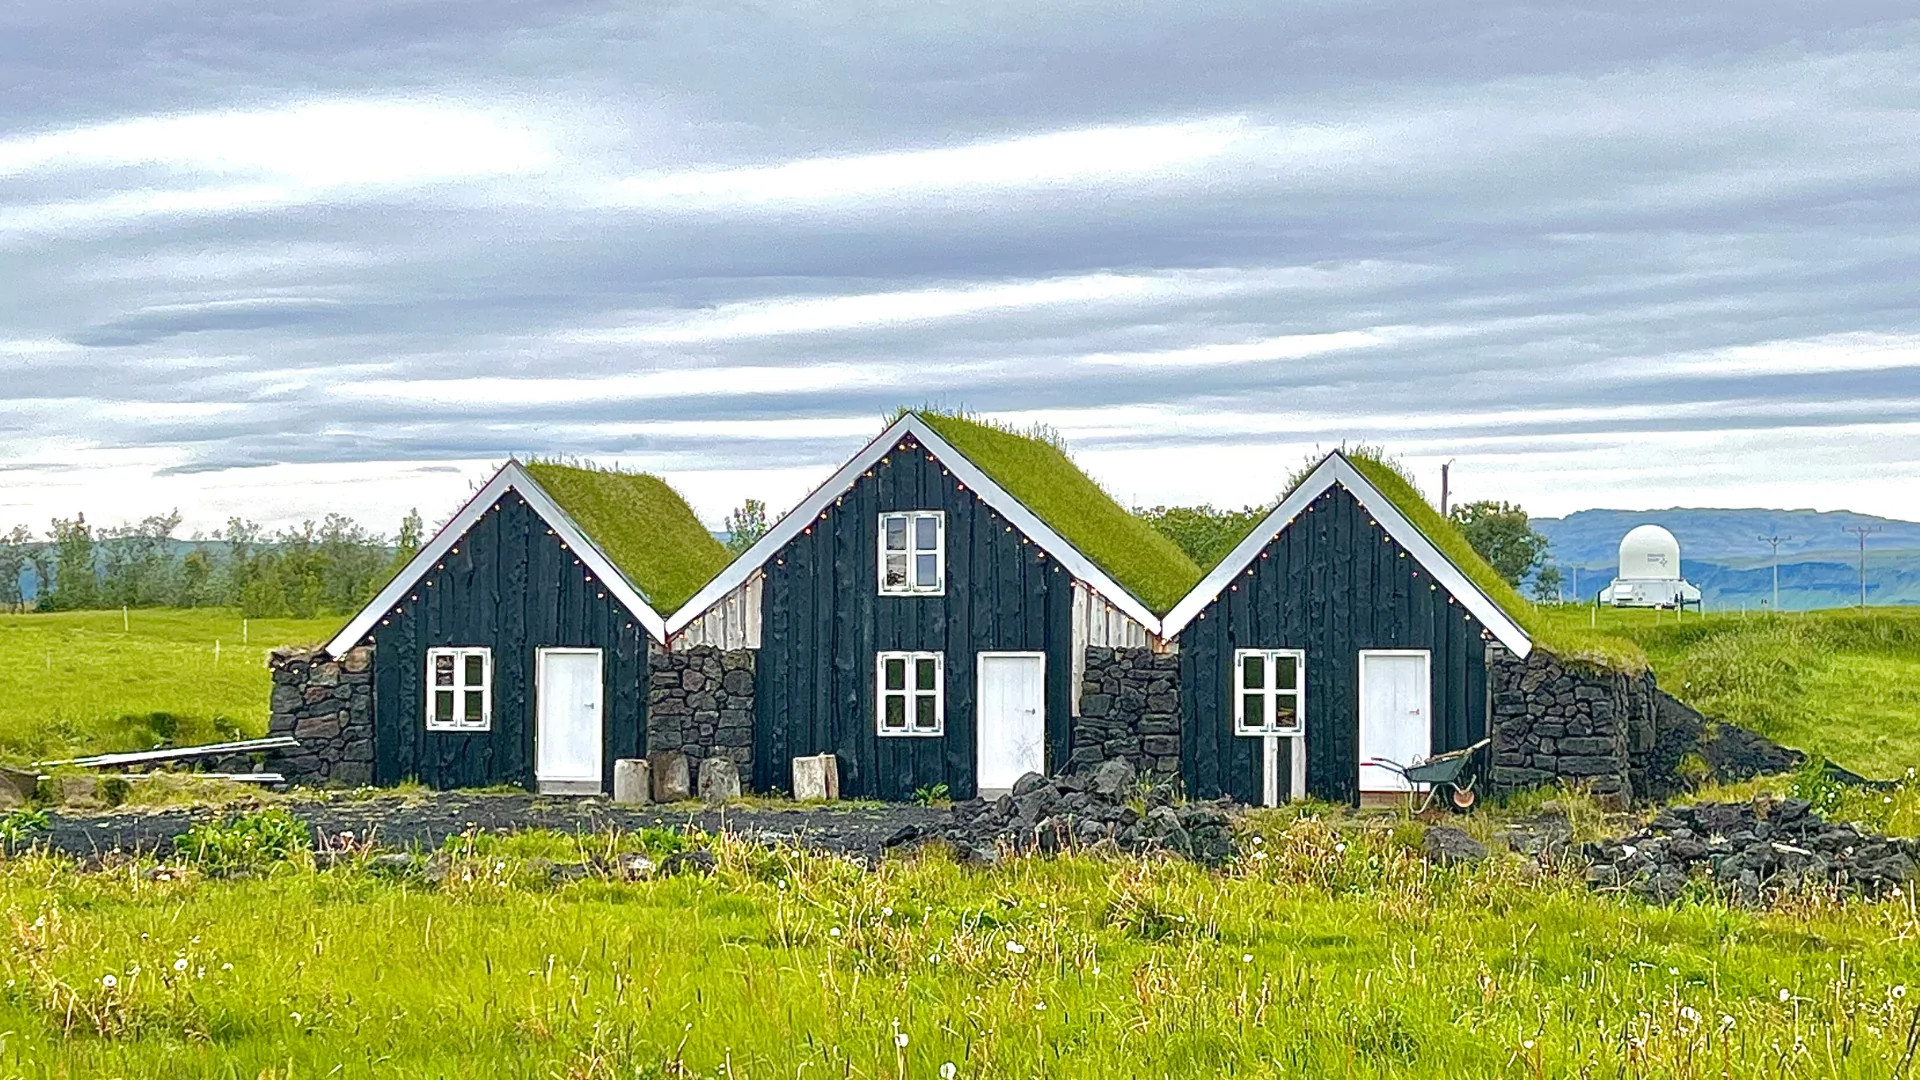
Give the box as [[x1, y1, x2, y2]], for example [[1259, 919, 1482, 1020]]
[[1068, 646, 1181, 782]]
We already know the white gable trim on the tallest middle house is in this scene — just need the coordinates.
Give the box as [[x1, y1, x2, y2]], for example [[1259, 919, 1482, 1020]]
[[666, 413, 1160, 636]]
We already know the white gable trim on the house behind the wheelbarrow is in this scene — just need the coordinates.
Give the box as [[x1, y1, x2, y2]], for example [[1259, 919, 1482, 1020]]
[[1160, 454, 1534, 657]]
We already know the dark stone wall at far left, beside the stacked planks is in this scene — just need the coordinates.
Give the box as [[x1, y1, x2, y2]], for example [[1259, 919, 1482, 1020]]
[[267, 646, 372, 788]]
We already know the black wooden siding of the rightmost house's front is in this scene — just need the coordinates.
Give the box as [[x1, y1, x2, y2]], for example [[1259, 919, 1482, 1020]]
[[1179, 486, 1486, 803]]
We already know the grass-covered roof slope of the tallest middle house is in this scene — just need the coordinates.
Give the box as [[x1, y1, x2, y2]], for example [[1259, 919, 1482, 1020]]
[[916, 409, 1200, 615]]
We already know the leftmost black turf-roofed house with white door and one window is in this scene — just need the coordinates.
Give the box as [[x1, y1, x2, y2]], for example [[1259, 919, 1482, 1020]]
[[326, 461, 728, 794]]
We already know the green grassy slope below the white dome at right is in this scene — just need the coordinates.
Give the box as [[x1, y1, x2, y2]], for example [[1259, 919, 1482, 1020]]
[[1544, 607, 1920, 776]]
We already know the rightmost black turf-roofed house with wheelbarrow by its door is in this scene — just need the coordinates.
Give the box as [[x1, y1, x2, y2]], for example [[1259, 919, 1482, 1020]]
[[1162, 454, 1532, 805]]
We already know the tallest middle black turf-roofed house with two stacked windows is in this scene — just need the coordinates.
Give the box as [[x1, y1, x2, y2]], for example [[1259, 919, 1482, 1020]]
[[666, 411, 1200, 799]]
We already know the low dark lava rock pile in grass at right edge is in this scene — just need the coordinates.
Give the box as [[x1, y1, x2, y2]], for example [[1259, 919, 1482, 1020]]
[[1586, 799, 1920, 905]]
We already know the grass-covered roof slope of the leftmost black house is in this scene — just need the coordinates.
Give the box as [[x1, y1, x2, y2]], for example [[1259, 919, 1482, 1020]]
[[526, 461, 733, 613]]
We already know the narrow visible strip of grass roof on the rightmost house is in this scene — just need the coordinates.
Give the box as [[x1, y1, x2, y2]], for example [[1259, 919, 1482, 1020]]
[[1344, 450, 1647, 673]]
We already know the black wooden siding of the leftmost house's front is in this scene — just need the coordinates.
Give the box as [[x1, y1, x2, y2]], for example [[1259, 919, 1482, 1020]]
[[371, 492, 649, 790]]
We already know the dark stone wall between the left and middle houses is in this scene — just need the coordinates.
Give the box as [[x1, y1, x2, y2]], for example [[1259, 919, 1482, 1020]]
[[647, 646, 755, 776]]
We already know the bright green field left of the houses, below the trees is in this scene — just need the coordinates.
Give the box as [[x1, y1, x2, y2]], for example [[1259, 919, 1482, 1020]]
[[0, 609, 342, 759]]
